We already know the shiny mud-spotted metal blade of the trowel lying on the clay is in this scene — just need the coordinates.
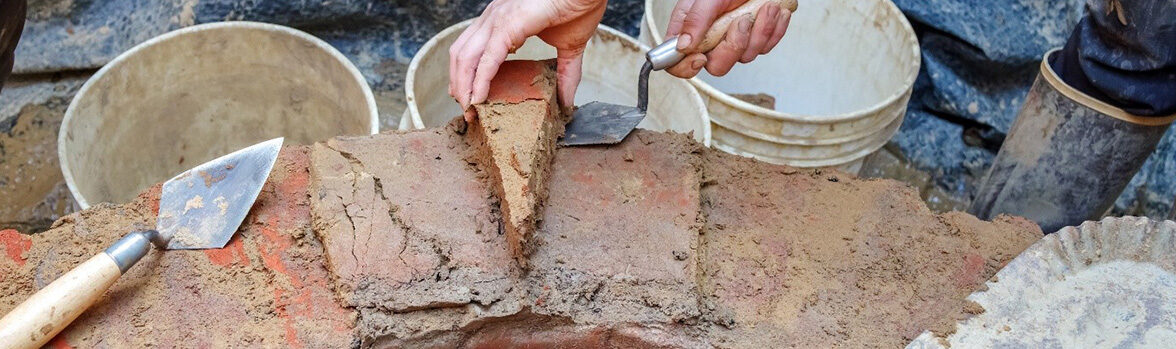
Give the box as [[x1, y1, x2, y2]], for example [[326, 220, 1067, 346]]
[[155, 139, 282, 249]]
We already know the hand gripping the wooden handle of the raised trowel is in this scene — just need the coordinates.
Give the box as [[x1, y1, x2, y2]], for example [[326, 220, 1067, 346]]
[[666, 0, 793, 79]]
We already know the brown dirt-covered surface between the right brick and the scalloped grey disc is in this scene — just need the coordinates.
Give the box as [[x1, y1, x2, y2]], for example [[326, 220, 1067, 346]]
[[701, 152, 1042, 348]]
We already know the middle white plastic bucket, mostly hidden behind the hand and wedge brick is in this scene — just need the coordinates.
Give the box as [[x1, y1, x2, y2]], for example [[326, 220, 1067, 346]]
[[401, 20, 710, 146]]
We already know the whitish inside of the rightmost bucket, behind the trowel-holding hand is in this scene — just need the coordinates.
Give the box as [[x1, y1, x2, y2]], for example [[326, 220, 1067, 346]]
[[652, 0, 920, 115]]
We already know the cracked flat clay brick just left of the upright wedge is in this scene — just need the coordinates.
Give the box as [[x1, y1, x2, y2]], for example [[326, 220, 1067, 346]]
[[312, 125, 519, 342]]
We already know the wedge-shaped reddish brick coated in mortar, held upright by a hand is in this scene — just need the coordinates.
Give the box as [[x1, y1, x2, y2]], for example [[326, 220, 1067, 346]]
[[468, 61, 568, 262]]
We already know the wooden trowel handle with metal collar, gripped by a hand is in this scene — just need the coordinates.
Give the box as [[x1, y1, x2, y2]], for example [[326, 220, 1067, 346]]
[[646, 0, 797, 71]]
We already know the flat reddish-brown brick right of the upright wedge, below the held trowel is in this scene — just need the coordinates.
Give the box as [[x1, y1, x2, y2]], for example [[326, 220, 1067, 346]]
[[530, 130, 701, 323]]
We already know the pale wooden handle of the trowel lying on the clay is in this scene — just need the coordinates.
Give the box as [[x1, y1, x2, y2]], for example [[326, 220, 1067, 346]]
[[0, 231, 151, 348]]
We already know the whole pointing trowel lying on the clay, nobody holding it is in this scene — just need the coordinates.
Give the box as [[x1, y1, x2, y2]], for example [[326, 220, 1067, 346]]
[[0, 139, 282, 348]]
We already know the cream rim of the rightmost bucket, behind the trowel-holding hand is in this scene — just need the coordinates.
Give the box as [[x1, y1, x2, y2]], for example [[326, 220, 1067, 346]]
[[641, 0, 922, 125]]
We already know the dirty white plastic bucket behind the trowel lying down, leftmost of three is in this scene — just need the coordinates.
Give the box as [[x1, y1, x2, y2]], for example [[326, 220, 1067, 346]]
[[58, 22, 379, 208]]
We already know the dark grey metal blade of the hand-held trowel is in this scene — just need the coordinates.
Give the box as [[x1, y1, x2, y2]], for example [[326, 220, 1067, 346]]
[[560, 102, 646, 146]]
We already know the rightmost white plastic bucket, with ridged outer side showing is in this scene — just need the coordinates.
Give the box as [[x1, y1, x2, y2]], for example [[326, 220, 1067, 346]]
[[642, 0, 921, 169]]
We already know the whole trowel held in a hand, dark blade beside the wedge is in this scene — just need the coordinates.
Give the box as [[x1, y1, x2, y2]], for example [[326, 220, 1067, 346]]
[[560, 0, 796, 146]]
